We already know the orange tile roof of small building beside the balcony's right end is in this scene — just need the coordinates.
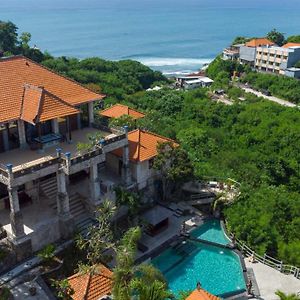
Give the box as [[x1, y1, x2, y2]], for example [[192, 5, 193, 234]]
[[113, 129, 178, 162]]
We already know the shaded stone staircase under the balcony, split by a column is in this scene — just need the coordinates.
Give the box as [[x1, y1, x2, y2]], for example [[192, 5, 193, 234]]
[[40, 177, 95, 234]]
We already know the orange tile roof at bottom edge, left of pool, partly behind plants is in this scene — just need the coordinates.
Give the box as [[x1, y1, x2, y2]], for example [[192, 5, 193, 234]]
[[68, 265, 113, 300]]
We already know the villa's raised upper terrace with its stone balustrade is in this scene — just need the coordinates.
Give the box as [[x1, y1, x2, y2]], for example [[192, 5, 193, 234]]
[[0, 128, 126, 184]]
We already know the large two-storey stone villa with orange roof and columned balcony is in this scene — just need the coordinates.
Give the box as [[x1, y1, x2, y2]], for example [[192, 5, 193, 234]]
[[0, 56, 131, 259]]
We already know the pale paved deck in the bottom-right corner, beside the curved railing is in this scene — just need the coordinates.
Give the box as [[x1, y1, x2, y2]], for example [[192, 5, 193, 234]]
[[245, 259, 300, 300]]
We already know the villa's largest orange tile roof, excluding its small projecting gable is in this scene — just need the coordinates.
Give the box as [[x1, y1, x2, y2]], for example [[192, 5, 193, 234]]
[[0, 56, 104, 123]]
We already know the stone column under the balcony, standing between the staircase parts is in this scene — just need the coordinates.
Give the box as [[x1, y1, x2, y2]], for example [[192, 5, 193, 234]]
[[56, 170, 70, 217]]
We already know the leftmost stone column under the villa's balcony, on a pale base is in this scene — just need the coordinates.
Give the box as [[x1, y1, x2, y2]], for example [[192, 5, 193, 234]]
[[7, 187, 25, 239]]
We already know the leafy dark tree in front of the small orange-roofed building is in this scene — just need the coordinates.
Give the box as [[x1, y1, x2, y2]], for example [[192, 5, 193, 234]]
[[153, 142, 194, 199]]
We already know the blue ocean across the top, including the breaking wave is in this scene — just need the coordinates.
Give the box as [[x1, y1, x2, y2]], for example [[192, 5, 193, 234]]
[[0, 0, 300, 74]]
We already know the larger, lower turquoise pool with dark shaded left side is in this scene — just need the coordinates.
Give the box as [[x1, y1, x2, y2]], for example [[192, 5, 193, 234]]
[[152, 241, 245, 296]]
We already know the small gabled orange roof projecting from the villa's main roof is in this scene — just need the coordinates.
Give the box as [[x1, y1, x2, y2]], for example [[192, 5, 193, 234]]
[[20, 84, 79, 125]]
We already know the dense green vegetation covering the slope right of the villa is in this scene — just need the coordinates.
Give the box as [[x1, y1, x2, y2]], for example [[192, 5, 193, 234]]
[[122, 90, 300, 265]]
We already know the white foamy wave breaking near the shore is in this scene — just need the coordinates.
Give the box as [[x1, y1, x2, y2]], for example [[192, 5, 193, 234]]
[[134, 57, 213, 67]]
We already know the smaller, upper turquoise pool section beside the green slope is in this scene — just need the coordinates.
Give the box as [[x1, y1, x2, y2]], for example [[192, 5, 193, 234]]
[[191, 220, 230, 245]]
